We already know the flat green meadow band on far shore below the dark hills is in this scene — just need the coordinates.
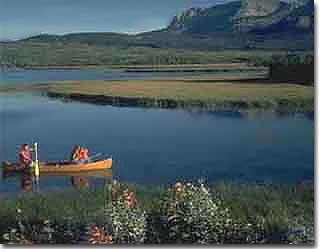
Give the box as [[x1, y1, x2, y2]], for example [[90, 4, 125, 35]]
[[0, 40, 313, 67]]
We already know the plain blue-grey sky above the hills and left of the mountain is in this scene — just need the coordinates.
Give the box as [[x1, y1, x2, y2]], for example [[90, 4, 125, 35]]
[[0, 0, 235, 40]]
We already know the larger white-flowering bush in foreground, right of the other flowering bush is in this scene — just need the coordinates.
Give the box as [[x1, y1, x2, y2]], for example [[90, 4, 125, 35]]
[[162, 181, 231, 244]]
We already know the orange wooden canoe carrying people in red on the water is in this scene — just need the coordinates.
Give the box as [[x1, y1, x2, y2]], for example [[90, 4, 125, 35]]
[[3, 158, 113, 174]]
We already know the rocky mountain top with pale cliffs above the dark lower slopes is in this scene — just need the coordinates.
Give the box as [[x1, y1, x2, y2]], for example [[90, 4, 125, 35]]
[[167, 0, 314, 34]]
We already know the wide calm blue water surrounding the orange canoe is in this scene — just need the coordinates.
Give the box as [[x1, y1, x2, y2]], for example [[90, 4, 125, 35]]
[[0, 94, 314, 196]]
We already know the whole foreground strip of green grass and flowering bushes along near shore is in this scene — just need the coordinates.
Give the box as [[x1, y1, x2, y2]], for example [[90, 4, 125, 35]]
[[0, 183, 314, 244]]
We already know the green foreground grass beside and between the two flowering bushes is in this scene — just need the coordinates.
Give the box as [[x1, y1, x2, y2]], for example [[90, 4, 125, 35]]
[[0, 180, 314, 244]]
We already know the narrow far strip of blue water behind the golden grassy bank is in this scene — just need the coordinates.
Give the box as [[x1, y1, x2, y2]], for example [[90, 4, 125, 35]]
[[0, 68, 264, 84]]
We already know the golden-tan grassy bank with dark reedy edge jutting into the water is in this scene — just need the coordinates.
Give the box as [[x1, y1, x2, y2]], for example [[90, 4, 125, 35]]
[[47, 79, 314, 112]]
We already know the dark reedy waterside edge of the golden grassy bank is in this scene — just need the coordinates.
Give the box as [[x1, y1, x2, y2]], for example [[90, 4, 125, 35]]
[[44, 91, 314, 114]]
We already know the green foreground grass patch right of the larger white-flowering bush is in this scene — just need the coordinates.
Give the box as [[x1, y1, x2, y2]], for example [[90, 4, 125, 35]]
[[214, 183, 314, 225]]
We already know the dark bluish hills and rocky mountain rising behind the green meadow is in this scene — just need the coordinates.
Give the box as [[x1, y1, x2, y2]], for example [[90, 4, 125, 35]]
[[15, 0, 314, 50]]
